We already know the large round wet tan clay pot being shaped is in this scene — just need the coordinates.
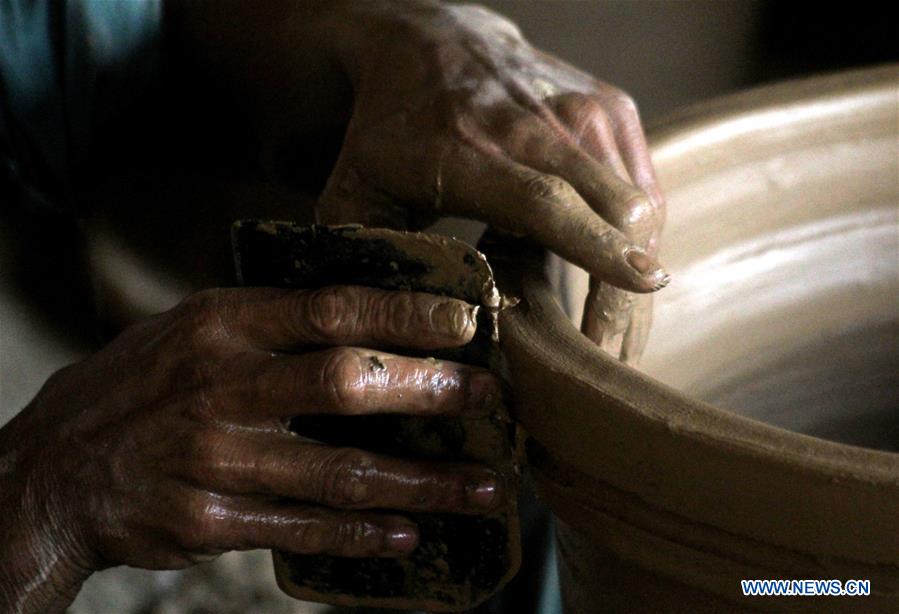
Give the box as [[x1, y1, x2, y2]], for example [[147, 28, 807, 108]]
[[488, 66, 899, 613]]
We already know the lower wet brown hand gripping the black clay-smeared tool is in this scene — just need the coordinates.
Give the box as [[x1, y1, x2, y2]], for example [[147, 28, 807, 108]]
[[0, 287, 505, 612]]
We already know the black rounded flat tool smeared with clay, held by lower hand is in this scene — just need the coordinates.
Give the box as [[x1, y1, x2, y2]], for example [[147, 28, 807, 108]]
[[232, 221, 521, 611]]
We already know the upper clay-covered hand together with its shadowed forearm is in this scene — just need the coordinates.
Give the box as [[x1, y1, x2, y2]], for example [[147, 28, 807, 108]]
[[172, 0, 668, 361]]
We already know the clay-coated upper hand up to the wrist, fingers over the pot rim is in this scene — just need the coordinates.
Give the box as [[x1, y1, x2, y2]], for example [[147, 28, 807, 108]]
[[321, 6, 668, 362]]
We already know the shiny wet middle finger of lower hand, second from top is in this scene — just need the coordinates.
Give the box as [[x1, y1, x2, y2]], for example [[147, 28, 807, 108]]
[[220, 347, 500, 418]]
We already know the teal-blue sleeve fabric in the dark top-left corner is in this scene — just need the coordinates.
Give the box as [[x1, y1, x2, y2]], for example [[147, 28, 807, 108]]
[[0, 0, 162, 212]]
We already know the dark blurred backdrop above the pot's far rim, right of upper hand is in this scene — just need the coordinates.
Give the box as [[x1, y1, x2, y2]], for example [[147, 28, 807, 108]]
[[481, 0, 899, 125]]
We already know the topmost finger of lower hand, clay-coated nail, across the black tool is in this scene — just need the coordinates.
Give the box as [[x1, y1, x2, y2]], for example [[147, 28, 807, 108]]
[[191, 286, 478, 350]]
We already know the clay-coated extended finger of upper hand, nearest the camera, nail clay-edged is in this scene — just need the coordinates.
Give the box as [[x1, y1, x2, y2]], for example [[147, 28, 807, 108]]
[[446, 151, 667, 292]]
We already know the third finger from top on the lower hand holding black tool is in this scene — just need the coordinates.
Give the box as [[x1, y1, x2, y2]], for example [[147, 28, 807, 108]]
[[206, 436, 505, 514]]
